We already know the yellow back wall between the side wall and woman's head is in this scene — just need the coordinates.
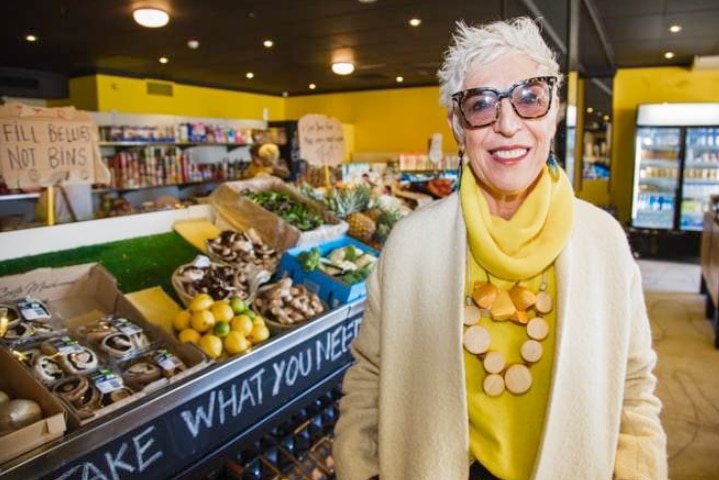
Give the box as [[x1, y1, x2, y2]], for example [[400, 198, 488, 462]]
[[285, 87, 457, 152]]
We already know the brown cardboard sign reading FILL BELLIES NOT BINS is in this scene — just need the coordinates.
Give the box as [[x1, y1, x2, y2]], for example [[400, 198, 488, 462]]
[[0, 103, 110, 188]]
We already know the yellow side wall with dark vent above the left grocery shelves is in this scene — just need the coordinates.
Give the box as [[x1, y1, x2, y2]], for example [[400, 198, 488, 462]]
[[82, 75, 285, 120]]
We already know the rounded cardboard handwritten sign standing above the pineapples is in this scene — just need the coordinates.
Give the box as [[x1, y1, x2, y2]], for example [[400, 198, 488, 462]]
[[297, 114, 345, 166]]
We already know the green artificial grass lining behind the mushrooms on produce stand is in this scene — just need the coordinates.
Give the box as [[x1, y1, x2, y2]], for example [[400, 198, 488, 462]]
[[0, 232, 201, 299]]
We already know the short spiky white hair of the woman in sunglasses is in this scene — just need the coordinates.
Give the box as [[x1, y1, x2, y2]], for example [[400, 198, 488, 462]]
[[437, 17, 561, 111]]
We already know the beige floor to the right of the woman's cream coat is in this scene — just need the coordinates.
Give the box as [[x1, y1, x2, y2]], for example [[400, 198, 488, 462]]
[[639, 260, 719, 480]]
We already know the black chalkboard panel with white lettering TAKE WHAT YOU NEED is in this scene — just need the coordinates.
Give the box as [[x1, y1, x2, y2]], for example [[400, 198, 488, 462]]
[[44, 311, 361, 480]]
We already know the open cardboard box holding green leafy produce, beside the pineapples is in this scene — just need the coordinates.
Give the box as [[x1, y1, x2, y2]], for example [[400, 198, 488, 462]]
[[210, 177, 349, 251]]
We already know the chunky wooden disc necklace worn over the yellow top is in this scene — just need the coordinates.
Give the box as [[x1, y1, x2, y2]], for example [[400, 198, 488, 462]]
[[462, 270, 553, 397]]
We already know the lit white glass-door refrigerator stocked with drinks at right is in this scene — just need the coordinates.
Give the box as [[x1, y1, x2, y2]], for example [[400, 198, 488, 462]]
[[632, 103, 719, 232]]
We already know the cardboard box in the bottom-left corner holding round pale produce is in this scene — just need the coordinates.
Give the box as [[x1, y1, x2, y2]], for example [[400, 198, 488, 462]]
[[0, 348, 67, 464]]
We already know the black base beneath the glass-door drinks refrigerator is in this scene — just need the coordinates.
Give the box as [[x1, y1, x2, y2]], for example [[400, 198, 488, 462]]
[[627, 228, 701, 263]]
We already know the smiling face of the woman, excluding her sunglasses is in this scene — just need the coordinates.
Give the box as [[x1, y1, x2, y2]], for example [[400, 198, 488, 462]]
[[463, 54, 558, 203]]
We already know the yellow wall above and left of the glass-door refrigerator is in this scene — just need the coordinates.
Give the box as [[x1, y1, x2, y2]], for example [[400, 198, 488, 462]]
[[610, 67, 719, 223]]
